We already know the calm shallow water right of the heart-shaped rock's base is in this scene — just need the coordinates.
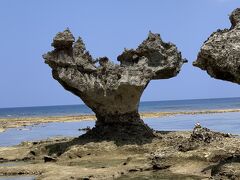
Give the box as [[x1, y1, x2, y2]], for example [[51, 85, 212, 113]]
[[145, 112, 240, 134]]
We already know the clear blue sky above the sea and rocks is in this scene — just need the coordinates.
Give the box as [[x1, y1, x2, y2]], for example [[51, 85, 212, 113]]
[[0, 0, 240, 108]]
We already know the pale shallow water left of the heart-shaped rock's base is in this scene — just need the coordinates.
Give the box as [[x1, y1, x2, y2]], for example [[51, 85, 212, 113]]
[[0, 121, 95, 146]]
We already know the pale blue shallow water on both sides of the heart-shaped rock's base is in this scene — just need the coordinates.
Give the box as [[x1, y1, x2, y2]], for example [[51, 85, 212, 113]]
[[0, 112, 240, 146]]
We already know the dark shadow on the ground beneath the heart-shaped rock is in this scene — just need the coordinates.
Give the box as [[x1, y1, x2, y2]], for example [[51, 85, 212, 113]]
[[45, 125, 157, 156]]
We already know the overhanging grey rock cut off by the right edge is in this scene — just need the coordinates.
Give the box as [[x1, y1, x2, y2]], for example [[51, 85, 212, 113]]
[[193, 8, 240, 84]]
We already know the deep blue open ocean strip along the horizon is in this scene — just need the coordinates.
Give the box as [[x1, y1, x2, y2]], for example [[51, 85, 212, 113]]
[[0, 97, 240, 118]]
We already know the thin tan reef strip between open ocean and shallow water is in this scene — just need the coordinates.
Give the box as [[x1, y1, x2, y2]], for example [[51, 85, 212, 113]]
[[0, 109, 240, 133]]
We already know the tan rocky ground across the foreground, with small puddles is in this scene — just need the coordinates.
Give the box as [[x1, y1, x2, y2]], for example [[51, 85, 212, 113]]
[[0, 125, 240, 180]]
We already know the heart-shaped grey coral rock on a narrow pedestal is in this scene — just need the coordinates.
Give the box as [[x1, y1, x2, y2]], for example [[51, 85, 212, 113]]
[[43, 29, 185, 139]]
